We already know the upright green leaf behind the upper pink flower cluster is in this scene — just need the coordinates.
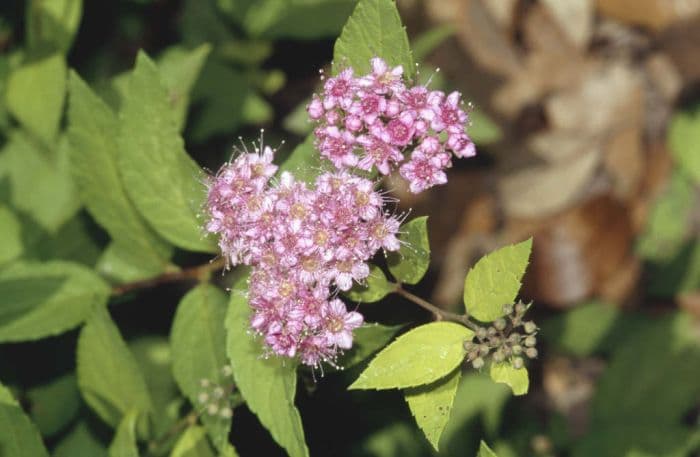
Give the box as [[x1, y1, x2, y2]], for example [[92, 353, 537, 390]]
[[333, 0, 415, 79]]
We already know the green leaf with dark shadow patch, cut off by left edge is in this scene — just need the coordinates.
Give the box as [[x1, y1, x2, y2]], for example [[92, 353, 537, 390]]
[[0, 261, 110, 342]]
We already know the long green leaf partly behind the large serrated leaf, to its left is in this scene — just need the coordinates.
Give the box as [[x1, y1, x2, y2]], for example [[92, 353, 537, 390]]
[[68, 72, 172, 280]]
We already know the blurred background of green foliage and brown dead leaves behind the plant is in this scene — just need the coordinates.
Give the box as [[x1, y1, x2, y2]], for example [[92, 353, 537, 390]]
[[0, 0, 700, 457]]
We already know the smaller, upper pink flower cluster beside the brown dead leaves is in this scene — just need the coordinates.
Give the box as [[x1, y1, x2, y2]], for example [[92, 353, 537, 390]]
[[307, 57, 476, 193]]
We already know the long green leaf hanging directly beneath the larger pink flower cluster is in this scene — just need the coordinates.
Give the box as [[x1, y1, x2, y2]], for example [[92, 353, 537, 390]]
[[226, 272, 309, 457]]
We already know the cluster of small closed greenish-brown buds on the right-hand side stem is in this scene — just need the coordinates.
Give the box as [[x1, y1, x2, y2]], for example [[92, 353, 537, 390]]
[[464, 302, 538, 369]]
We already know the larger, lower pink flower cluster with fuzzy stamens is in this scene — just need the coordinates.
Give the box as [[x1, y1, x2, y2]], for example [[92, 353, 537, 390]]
[[206, 147, 400, 366]]
